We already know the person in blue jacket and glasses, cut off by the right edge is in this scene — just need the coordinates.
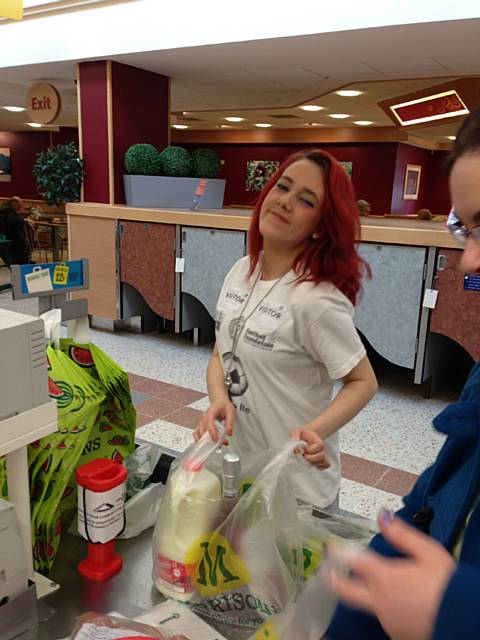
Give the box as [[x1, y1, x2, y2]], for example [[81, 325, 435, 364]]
[[326, 109, 480, 640]]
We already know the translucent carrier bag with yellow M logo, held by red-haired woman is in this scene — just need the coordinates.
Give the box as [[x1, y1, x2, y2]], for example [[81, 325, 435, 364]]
[[154, 434, 303, 629]]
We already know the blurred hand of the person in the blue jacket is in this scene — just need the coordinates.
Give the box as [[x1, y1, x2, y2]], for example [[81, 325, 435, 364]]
[[327, 511, 461, 640]]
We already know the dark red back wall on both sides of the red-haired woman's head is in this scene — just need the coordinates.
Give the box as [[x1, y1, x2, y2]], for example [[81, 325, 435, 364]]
[[185, 143, 397, 213]]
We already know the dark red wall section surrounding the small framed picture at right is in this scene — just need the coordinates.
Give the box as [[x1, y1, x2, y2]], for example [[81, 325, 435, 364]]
[[391, 144, 450, 215]]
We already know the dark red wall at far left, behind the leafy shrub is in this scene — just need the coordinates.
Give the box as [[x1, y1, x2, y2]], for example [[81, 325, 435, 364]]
[[0, 127, 78, 200]]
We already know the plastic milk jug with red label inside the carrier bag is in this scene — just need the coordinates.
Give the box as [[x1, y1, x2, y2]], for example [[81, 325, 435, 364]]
[[154, 457, 222, 602]]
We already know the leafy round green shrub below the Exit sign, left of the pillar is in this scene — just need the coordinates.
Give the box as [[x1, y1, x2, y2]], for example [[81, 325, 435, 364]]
[[33, 142, 84, 207]]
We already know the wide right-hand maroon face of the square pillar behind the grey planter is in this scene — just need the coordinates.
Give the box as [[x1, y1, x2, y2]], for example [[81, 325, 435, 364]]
[[111, 62, 169, 204]]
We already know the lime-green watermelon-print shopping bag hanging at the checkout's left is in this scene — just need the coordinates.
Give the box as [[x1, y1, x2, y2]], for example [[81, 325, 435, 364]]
[[29, 339, 136, 571]]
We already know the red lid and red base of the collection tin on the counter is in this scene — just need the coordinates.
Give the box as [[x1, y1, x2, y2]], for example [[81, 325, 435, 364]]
[[76, 458, 127, 580]]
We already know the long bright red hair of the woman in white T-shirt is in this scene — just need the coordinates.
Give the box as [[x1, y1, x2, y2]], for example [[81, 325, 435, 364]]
[[248, 149, 370, 304]]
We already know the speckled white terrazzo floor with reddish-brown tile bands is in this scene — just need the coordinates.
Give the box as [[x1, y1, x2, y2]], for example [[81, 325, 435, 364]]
[[0, 269, 457, 517]]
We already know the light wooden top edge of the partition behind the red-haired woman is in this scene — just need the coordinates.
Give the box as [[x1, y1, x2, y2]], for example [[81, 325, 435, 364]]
[[66, 202, 460, 249]]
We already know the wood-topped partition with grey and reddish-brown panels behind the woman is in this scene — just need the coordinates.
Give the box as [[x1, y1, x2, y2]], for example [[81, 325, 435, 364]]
[[67, 203, 480, 384]]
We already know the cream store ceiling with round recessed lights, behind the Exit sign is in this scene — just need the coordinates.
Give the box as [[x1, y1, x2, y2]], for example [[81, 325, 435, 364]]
[[0, 19, 480, 143]]
